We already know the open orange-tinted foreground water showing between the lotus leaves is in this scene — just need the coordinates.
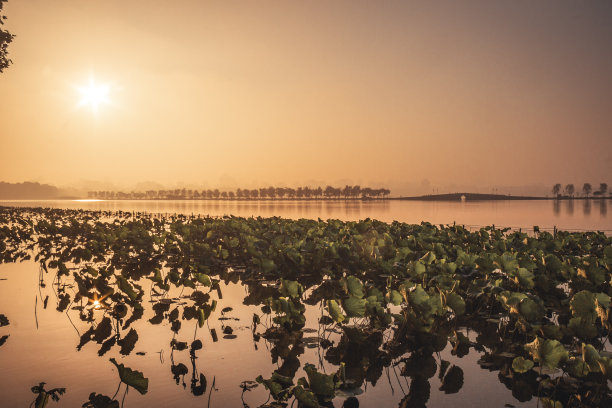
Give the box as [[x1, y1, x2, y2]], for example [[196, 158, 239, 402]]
[[0, 261, 537, 408]]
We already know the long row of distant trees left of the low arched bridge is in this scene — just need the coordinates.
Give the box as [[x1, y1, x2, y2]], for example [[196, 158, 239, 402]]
[[87, 185, 391, 200]]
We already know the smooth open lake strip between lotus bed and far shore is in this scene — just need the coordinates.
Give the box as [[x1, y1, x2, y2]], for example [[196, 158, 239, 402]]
[[0, 200, 612, 232]]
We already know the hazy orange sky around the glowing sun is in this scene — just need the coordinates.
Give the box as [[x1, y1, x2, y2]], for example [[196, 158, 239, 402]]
[[0, 0, 612, 193]]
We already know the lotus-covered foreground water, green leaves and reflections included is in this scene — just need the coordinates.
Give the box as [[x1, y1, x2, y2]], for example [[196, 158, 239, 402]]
[[0, 208, 612, 408]]
